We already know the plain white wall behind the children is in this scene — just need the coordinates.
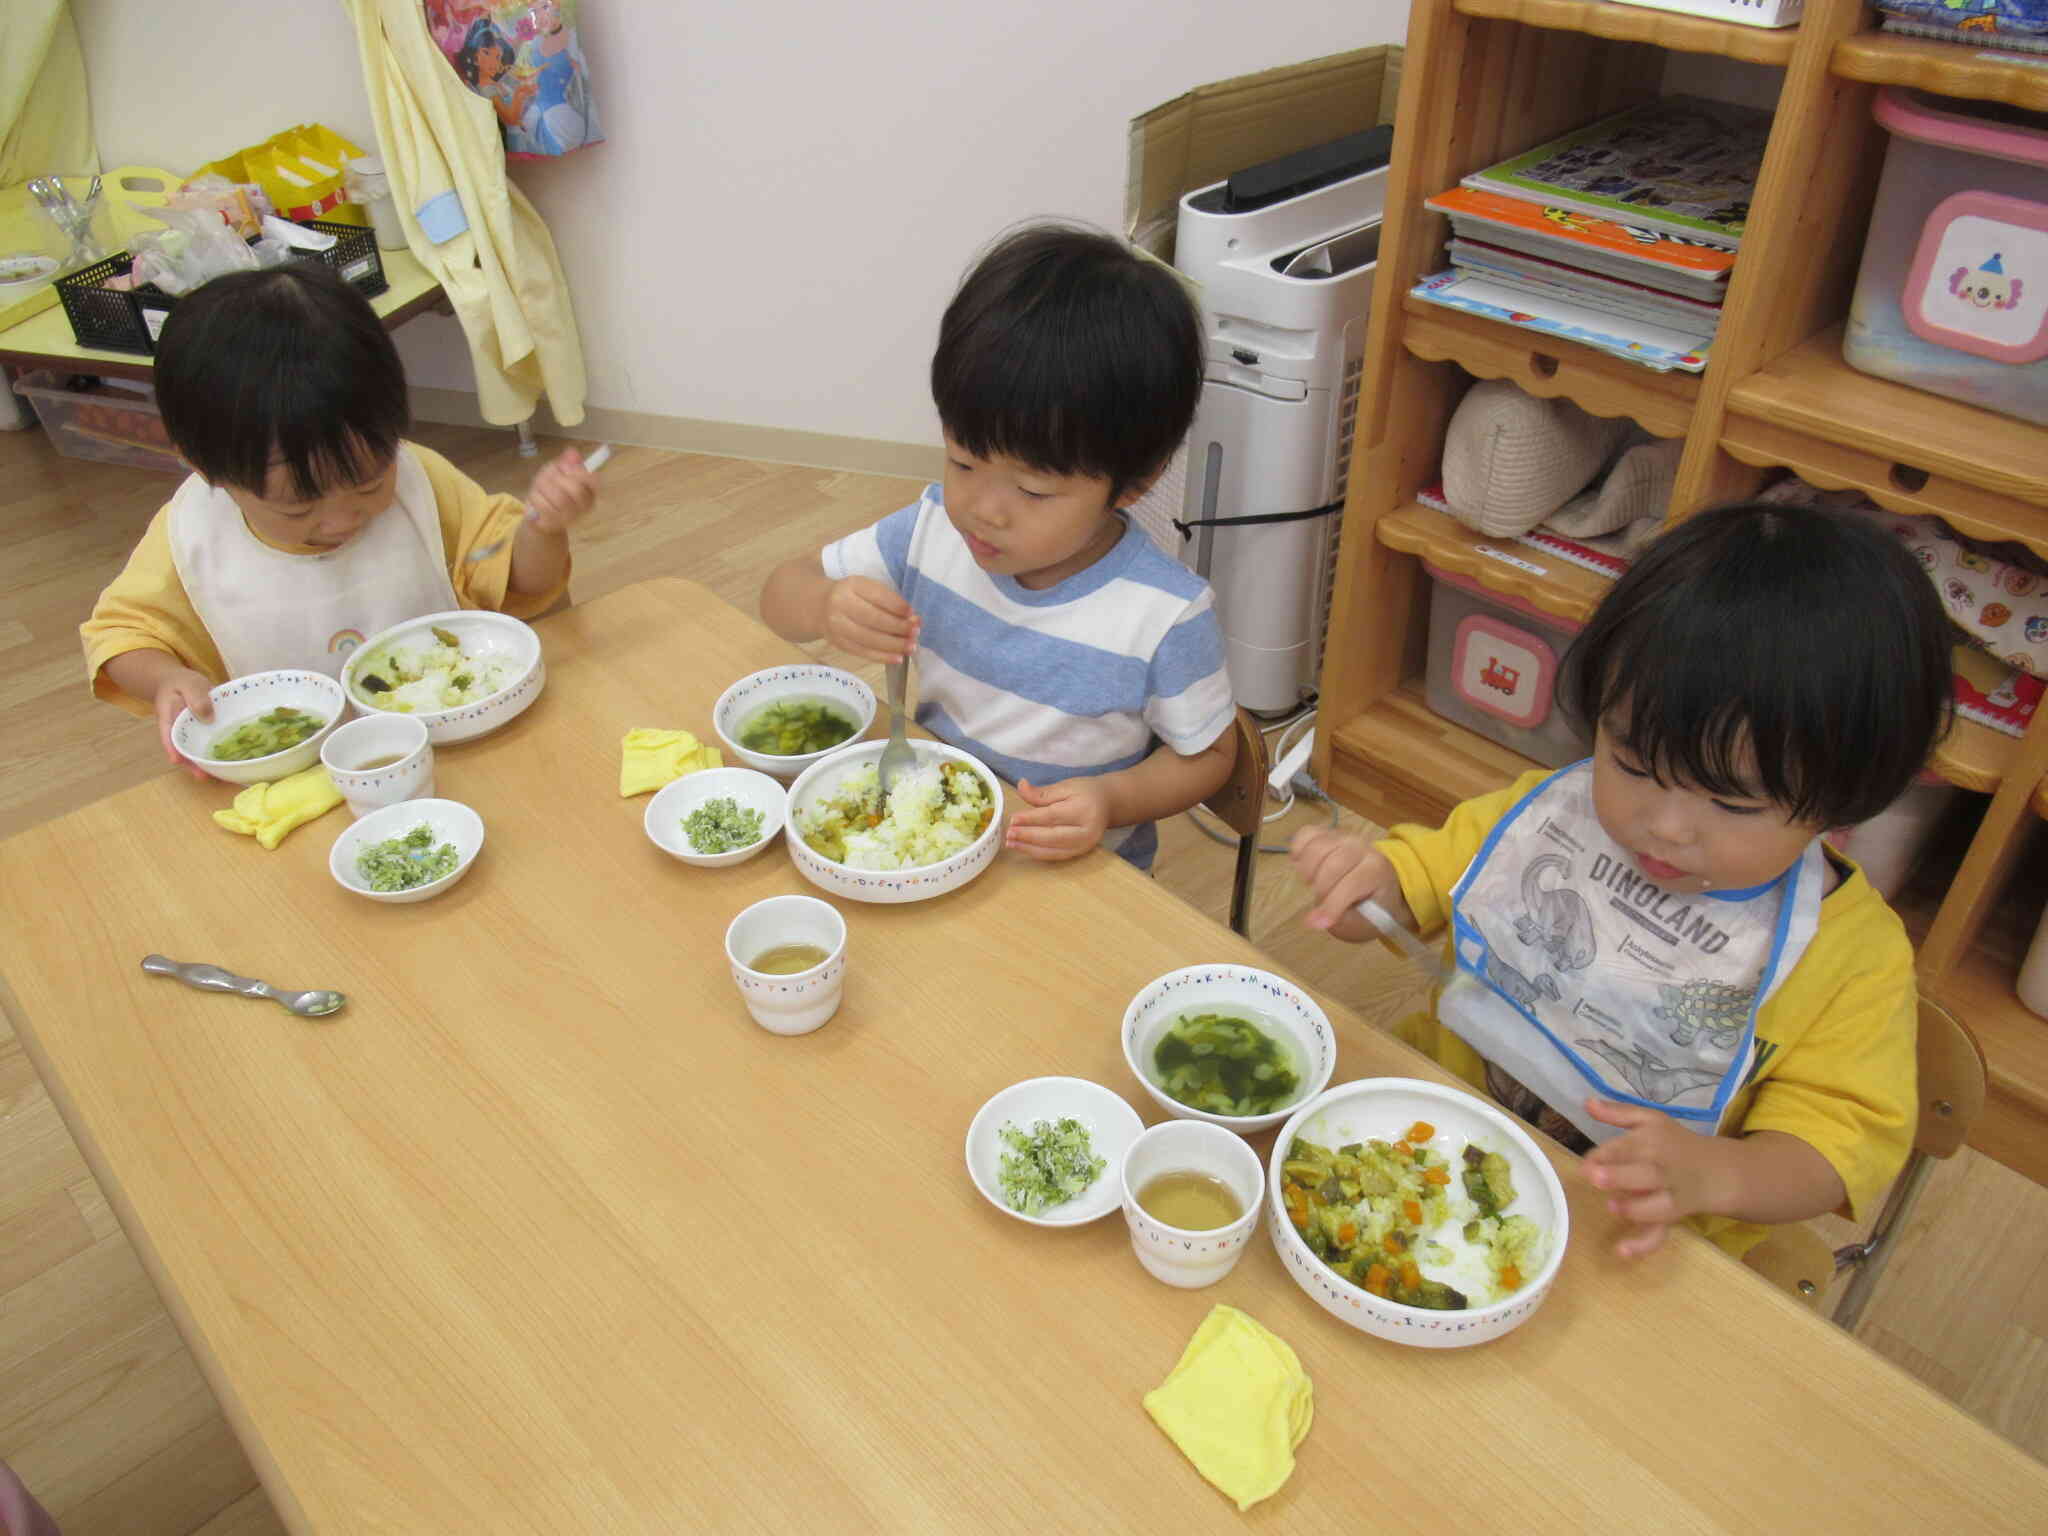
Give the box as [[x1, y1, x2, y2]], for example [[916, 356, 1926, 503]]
[[72, 0, 1407, 442]]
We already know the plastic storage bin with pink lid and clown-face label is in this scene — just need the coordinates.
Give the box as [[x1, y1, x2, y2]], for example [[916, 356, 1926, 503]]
[[1841, 86, 2048, 422]]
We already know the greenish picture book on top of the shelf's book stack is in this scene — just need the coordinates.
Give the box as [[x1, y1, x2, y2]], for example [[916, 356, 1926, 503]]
[[1464, 96, 1772, 250]]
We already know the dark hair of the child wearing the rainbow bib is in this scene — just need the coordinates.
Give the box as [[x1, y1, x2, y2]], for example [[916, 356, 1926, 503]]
[[156, 264, 410, 502]]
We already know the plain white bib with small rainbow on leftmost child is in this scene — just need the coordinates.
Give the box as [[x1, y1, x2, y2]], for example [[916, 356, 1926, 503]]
[[170, 444, 461, 678]]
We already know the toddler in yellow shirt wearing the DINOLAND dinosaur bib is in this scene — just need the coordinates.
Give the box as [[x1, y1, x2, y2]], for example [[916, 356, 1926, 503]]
[[1292, 504, 1950, 1255]]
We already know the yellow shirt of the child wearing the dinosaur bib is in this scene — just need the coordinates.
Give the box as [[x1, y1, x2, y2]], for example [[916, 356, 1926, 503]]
[[1376, 770, 1919, 1255]]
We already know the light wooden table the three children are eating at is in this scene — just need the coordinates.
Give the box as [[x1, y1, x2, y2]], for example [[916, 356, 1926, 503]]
[[0, 582, 2048, 1536]]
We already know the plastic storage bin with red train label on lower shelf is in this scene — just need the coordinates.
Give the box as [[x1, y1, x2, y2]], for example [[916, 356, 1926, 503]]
[[1423, 561, 1593, 768]]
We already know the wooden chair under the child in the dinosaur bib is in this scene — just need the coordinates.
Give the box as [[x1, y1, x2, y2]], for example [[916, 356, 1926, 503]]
[[1743, 997, 1985, 1329]]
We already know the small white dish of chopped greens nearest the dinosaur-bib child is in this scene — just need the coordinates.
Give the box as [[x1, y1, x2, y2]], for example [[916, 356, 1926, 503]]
[[967, 1077, 1145, 1227]]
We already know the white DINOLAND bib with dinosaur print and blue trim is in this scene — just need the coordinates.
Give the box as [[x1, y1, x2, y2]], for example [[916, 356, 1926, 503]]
[[1438, 762, 1825, 1141]]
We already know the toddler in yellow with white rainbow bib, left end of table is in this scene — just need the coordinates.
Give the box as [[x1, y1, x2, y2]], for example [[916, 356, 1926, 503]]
[[80, 264, 596, 774]]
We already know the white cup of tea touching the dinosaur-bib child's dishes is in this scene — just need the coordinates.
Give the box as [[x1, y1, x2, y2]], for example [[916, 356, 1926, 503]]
[[1122, 1120, 1266, 1290]]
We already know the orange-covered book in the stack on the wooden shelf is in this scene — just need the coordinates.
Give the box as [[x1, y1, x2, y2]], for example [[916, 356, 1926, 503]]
[[1425, 186, 1735, 301]]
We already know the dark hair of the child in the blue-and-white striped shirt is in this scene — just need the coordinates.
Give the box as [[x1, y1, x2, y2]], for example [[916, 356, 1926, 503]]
[[932, 225, 1202, 500]]
